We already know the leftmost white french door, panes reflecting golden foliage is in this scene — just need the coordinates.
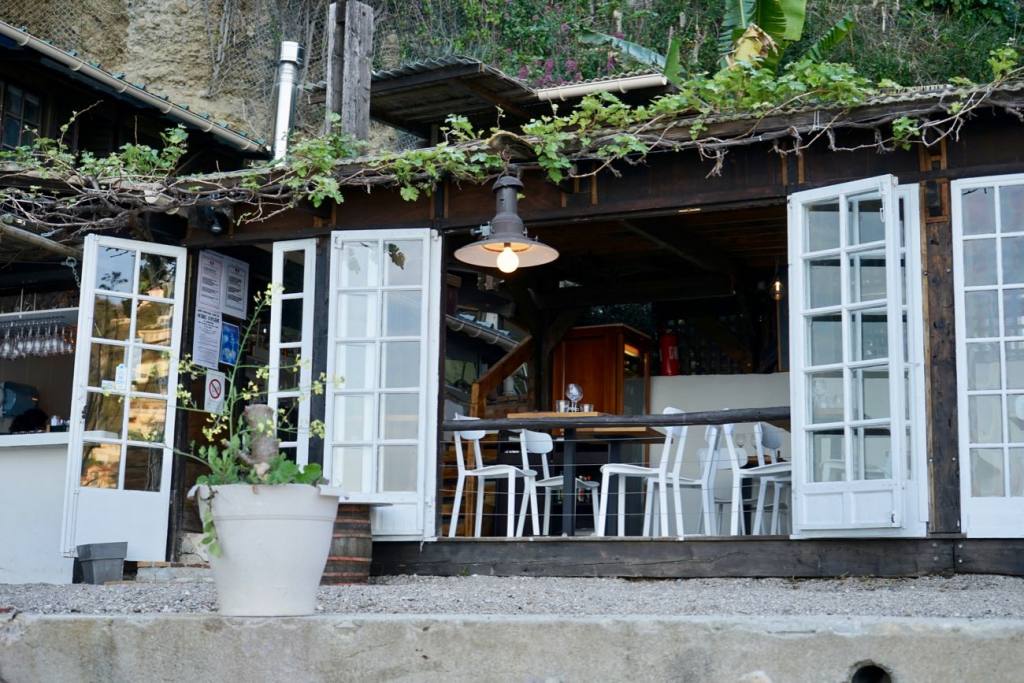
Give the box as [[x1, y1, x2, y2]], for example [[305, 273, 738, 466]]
[[63, 234, 185, 560]]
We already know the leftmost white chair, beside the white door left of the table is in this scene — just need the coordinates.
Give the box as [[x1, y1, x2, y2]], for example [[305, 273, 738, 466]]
[[449, 415, 538, 538]]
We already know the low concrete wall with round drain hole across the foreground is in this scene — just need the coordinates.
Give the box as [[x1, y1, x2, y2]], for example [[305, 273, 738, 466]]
[[0, 614, 1024, 683]]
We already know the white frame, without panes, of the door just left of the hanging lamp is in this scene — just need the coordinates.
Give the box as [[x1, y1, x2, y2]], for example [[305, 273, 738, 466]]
[[324, 228, 442, 541]]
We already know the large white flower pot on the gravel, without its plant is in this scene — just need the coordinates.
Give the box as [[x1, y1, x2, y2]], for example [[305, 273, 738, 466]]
[[200, 484, 338, 616]]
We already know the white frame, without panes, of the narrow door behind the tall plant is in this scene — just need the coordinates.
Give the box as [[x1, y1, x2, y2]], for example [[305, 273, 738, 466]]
[[267, 238, 316, 467]]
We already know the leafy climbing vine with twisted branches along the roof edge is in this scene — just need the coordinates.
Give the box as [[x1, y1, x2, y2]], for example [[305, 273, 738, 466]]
[[0, 46, 1024, 242]]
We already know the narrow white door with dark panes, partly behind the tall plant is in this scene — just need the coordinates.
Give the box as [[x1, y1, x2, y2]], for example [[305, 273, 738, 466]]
[[267, 239, 316, 466]]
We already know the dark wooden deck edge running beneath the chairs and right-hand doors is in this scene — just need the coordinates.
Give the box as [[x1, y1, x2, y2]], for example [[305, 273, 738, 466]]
[[371, 537, 1024, 579]]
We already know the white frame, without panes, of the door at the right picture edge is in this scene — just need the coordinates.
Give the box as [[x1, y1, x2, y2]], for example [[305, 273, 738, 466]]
[[950, 173, 1024, 539]]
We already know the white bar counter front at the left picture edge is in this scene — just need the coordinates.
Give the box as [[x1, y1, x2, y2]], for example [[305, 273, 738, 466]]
[[0, 433, 74, 584]]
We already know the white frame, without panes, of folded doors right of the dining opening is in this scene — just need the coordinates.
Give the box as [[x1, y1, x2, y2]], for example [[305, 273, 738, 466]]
[[790, 175, 927, 538]]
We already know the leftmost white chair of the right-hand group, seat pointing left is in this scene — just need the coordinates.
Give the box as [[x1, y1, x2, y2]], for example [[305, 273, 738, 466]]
[[595, 408, 691, 537]]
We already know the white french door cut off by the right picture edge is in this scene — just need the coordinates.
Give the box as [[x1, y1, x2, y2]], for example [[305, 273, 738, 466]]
[[951, 174, 1024, 538]]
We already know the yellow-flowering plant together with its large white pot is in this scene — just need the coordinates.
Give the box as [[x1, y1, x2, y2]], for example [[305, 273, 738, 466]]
[[178, 288, 338, 616]]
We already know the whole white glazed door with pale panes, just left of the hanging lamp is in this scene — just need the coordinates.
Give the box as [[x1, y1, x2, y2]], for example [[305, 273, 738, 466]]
[[324, 228, 441, 539]]
